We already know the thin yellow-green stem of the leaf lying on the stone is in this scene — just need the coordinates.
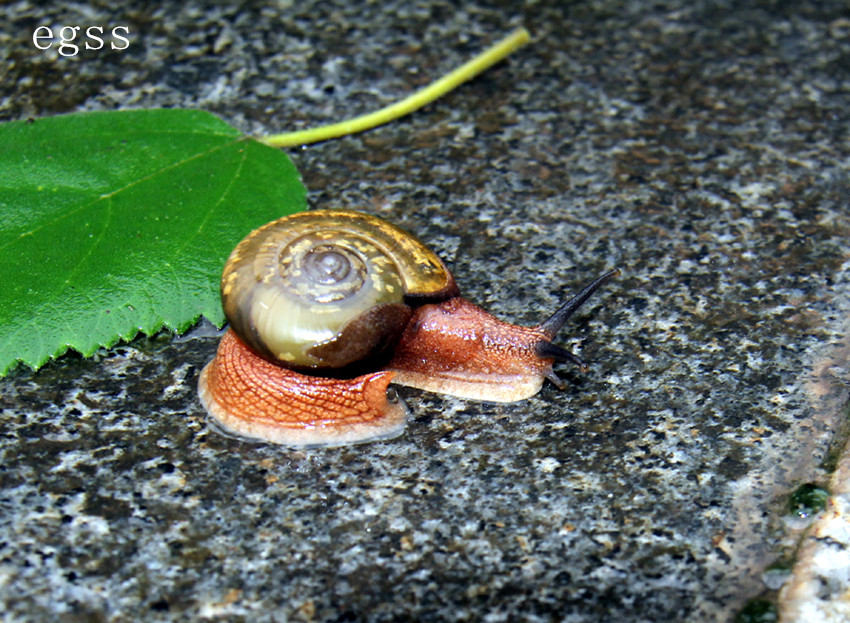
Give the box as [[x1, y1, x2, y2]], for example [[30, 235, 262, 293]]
[[258, 28, 531, 147]]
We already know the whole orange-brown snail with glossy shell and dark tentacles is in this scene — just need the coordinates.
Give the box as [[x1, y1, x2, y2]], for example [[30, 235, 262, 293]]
[[198, 210, 619, 446]]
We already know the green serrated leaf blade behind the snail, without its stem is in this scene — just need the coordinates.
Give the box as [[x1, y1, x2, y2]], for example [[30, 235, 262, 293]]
[[0, 110, 306, 375]]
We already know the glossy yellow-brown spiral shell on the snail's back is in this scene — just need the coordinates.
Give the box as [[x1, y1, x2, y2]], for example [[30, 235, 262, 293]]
[[221, 210, 457, 369]]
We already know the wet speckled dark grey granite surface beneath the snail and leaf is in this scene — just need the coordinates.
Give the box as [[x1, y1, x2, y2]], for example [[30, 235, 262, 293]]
[[0, 0, 850, 623]]
